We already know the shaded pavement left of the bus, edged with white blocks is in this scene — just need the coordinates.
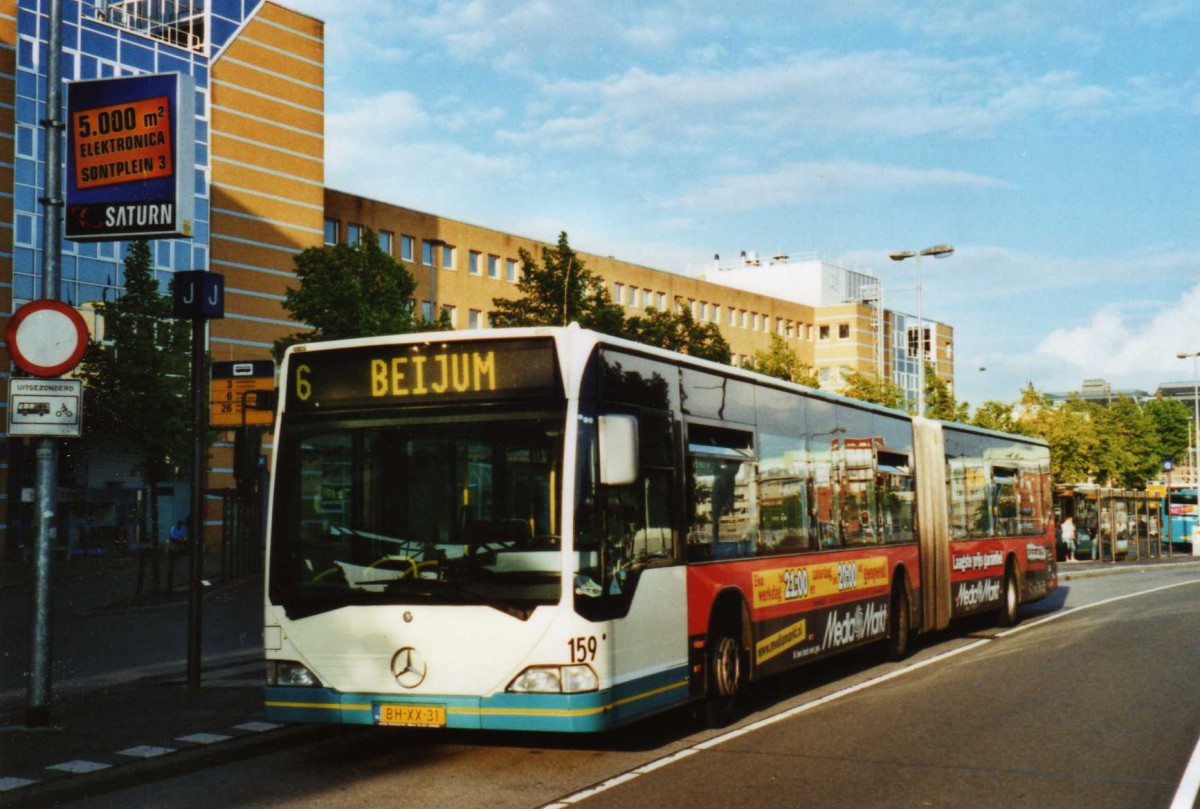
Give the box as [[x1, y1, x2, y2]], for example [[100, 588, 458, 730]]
[[0, 558, 309, 809]]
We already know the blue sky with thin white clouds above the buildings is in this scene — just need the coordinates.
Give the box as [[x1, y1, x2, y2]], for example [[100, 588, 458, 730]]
[[281, 0, 1200, 405]]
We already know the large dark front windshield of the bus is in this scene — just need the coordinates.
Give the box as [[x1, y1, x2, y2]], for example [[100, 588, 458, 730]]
[[270, 408, 564, 617]]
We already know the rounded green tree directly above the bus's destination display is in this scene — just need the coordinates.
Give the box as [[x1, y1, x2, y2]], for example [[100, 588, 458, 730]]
[[275, 229, 441, 360]]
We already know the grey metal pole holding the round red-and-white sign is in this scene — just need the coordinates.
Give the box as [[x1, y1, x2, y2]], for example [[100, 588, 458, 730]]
[[25, 0, 64, 727]]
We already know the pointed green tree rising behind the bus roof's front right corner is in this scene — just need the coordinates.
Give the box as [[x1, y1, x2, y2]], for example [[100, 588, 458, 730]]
[[490, 232, 625, 336]]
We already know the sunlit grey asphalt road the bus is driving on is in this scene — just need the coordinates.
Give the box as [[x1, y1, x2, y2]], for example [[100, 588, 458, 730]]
[[44, 568, 1200, 809]]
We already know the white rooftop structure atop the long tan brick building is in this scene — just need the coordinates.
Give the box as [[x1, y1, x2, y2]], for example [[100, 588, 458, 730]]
[[688, 251, 880, 306]]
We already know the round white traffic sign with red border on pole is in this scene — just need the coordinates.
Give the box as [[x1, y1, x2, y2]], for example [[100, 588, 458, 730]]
[[5, 300, 88, 377]]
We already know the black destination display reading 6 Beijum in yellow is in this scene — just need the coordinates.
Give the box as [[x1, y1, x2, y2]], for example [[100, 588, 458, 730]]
[[287, 340, 562, 412]]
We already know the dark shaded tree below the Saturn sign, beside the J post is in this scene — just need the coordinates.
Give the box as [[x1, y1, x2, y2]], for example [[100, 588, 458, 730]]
[[79, 240, 192, 549]]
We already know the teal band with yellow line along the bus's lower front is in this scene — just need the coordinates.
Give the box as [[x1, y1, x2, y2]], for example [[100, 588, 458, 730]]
[[264, 667, 689, 732]]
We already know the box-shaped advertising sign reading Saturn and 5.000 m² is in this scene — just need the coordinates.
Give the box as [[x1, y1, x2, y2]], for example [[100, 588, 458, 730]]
[[66, 73, 196, 241]]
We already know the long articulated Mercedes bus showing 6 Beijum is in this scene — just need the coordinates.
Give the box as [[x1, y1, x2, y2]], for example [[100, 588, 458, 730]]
[[264, 325, 1057, 731]]
